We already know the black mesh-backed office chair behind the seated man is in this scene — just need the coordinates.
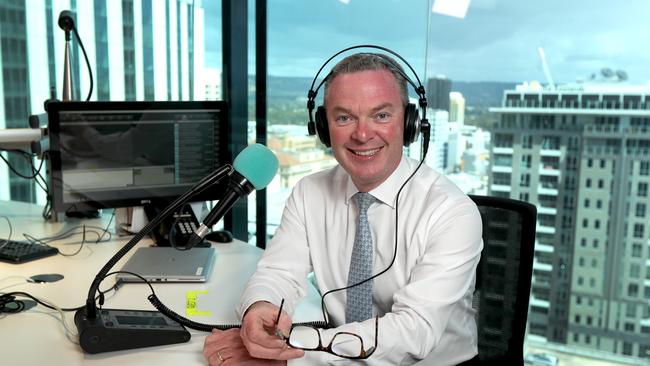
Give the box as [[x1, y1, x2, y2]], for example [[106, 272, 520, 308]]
[[470, 195, 537, 365]]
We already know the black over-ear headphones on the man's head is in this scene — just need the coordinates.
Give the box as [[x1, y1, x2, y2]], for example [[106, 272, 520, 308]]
[[307, 45, 431, 149]]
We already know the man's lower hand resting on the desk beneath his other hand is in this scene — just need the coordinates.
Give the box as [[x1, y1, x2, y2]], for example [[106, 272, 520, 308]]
[[203, 329, 287, 366]]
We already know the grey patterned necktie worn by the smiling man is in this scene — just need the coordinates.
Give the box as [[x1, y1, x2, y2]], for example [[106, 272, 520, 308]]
[[345, 192, 375, 323]]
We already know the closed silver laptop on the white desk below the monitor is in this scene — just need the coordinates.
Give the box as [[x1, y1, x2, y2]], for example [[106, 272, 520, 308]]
[[117, 247, 216, 283]]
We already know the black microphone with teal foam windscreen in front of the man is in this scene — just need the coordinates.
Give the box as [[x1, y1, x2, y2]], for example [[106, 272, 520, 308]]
[[185, 144, 278, 249]]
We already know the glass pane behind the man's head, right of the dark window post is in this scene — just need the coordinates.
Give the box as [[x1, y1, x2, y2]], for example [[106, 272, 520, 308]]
[[267, 0, 429, 236]]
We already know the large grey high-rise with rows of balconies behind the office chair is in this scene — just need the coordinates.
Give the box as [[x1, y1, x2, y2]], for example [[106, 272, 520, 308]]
[[489, 82, 650, 358]]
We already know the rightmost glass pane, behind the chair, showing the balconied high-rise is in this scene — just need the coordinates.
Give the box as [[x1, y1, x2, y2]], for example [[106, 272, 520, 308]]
[[426, 0, 650, 364]]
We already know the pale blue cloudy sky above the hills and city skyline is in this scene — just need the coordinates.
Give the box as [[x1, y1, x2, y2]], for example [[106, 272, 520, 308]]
[[204, 0, 650, 84]]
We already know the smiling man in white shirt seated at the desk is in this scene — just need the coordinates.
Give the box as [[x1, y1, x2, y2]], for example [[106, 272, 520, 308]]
[[204, 53, 483, 365]]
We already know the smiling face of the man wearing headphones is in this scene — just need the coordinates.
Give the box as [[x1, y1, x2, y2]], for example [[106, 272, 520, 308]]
[[325, 70, 404, 192]]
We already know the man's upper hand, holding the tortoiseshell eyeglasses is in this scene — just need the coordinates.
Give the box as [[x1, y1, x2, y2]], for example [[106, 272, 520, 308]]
[[240, 301, 305, 360]]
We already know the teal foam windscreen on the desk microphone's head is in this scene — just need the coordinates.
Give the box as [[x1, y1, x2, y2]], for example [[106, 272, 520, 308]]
[[232, 144, 278, 189]]
